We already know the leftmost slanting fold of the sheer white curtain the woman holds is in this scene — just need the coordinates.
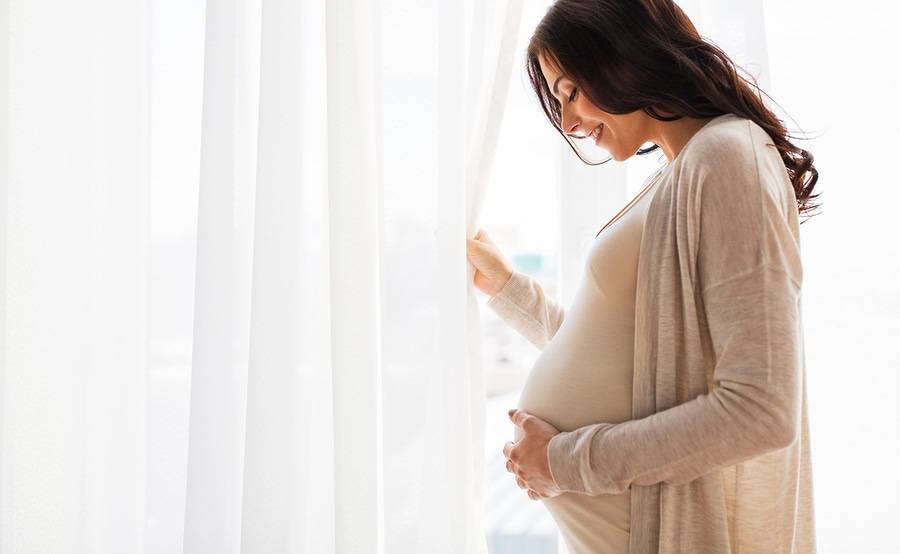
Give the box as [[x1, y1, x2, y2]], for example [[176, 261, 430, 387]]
[[183, 0, 260, 553]]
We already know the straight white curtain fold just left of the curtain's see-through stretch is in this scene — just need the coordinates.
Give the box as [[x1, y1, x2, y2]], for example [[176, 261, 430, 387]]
[[322, 0, 387, 552]]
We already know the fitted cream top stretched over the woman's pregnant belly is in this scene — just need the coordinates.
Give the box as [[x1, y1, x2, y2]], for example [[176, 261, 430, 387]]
[[514, 166, 665, 554]]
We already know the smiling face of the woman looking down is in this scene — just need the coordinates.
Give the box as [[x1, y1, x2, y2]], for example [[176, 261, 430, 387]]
[[538, 54, 654, 161]]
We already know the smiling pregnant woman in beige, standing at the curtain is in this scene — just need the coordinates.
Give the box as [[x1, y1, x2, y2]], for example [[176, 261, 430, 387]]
[[467, 0, 818, 554]]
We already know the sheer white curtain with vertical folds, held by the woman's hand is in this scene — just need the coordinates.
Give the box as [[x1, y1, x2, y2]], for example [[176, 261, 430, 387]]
[[184, 0, 520, 553]]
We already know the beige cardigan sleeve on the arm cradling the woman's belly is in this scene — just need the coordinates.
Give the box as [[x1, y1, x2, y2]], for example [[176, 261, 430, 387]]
[[548, 126, 803, 495]]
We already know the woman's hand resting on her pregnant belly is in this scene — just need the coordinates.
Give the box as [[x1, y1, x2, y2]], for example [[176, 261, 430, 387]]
[[503, 409, 562, 500]]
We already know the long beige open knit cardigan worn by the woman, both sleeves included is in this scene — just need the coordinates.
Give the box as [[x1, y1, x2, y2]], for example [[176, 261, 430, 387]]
[[488, 114, 816, 554]]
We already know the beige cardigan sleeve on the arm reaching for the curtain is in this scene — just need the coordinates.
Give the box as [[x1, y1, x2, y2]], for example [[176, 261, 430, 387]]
[[487, 270, 565, 350]]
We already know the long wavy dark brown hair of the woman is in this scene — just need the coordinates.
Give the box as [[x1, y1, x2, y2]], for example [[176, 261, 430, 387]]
[[525, 0, 819, 223]]
